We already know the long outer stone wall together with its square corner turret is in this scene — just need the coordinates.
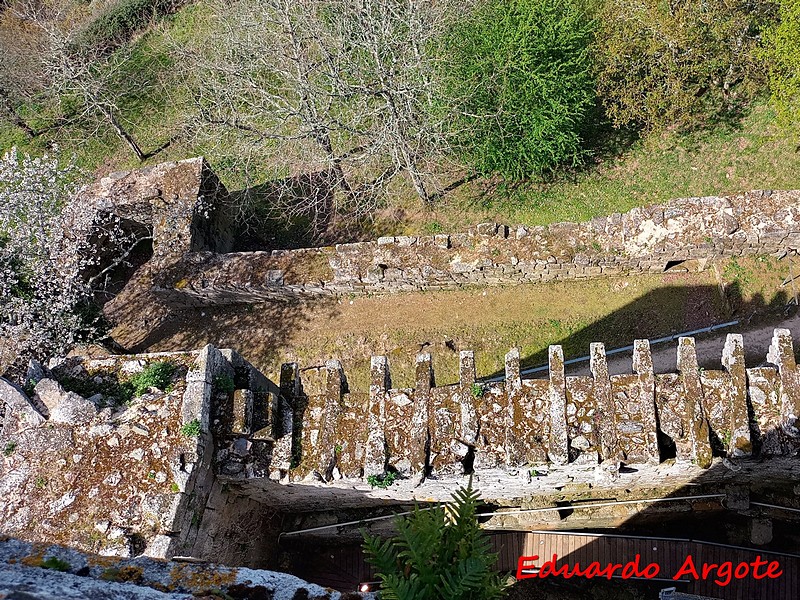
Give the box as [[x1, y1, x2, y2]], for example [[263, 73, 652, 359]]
[[79, 158, 800, 307]]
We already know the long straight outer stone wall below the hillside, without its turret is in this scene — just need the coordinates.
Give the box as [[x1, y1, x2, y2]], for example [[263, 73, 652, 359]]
[[153, 191, 800, 306]]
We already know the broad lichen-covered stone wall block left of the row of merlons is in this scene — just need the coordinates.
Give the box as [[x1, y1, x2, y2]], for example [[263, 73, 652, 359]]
[[0, 346, 277, 565]]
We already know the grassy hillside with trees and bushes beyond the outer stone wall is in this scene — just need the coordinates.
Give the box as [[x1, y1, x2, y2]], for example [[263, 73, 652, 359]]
[[0, 0, 800, 247]]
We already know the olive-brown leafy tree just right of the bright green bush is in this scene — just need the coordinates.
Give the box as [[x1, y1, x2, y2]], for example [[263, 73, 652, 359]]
[[596, 0, 774, 130]]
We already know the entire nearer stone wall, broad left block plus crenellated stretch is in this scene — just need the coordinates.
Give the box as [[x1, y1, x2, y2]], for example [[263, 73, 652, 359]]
[[0, 329, 800, 567]]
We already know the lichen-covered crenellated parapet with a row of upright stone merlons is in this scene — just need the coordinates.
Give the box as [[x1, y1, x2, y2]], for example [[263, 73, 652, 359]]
[[255, 329, 800, 481]]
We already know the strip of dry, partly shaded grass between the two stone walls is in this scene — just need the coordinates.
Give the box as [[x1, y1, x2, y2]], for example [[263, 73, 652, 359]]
[[122, 257, 791, 391]]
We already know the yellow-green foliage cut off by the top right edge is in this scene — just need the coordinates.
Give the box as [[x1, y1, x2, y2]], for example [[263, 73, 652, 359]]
[[764, 0, 800, 122]]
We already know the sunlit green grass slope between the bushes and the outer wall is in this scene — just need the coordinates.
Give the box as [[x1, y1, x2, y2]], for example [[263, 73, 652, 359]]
[[390, 102, 800, 233]]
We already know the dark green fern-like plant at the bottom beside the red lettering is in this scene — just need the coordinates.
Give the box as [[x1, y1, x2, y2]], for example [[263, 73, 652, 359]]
[[364, 485, 505, 600]]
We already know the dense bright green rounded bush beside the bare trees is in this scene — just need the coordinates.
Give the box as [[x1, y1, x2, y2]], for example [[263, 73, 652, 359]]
[[442, 0, 595, 180]]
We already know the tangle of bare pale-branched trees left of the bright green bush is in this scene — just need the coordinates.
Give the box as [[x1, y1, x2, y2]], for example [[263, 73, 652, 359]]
[[178, 0, 460, 239]]
